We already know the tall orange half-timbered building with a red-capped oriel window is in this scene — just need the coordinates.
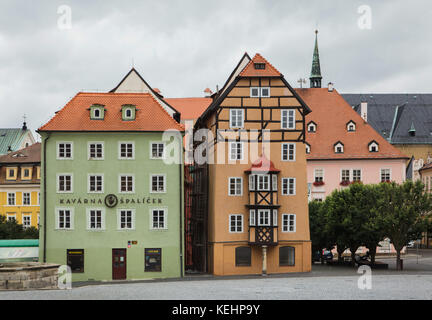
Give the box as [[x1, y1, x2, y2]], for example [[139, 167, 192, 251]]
[[192, 53, 311, 275]]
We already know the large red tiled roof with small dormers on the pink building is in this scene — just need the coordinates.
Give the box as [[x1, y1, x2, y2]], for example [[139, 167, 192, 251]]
[[296, 88, 408, 160]]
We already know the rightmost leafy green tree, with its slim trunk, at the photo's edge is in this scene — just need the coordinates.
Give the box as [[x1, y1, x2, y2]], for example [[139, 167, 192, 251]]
[[375, 180, 432, 270]]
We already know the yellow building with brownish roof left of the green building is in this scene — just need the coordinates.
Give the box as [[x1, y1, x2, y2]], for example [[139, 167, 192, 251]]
[[0, 143, 41, 228]]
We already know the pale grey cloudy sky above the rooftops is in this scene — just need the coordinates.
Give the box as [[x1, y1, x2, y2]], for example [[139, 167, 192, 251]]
[[0, 0, 432, 136]]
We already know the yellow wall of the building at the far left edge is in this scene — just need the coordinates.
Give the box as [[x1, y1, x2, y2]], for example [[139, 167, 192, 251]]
[[0, 187, 40, 228]]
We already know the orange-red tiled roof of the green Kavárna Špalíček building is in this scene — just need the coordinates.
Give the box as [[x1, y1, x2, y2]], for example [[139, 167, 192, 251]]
[[39, 92, 184, 131]]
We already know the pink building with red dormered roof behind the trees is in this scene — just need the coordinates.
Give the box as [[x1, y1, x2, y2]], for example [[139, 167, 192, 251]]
[[296, 86, 409, 201]]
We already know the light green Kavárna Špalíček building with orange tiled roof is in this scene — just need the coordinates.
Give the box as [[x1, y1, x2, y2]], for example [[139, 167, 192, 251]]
[[39, 93, 184, 281]]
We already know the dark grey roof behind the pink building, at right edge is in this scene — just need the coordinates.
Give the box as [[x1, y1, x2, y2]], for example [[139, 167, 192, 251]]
[[342, 93, 432, 144]]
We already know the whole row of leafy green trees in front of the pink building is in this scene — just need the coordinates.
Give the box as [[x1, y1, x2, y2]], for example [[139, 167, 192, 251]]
[[309, 181, 432, 263]]
